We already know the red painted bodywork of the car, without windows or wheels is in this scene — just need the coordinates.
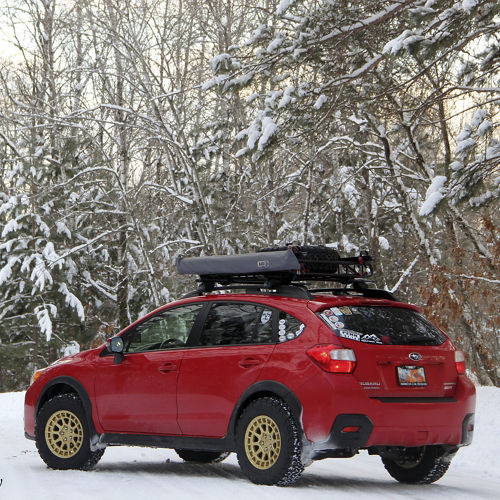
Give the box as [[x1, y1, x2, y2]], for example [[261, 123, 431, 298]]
[[25, 294, 475, 452]]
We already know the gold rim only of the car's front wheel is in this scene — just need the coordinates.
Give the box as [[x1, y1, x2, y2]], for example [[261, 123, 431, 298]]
[[45, 410, 83, 458]]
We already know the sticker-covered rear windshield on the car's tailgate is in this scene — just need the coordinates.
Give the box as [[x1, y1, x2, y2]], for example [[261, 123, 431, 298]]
[[319, 306, 446, 345]]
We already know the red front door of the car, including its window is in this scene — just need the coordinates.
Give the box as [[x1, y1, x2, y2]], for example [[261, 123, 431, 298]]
[[95, 304, 203, 435]]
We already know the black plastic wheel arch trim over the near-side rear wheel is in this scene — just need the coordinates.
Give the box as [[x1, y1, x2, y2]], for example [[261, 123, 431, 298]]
[[229, 380, 302, 439]]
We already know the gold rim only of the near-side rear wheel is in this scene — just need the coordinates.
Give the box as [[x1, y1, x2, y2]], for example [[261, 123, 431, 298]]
[[245, 415, 281, 470]]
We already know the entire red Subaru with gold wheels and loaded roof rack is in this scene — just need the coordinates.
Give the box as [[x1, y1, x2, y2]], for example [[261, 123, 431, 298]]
[[25, 247, 475, 485]]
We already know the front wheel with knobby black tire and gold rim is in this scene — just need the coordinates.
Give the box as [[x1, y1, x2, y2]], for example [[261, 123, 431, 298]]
[[35, 394, 104, 470]]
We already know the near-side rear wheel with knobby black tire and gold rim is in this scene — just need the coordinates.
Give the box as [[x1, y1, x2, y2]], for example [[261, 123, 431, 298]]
[[236, 397, 304, 486]]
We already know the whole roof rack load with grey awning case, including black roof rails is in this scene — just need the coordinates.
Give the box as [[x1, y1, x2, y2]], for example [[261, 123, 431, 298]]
[[176, 245, 396, 300]]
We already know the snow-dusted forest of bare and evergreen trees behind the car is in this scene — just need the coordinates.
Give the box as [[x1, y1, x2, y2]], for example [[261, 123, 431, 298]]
[[0, 0, 500, 391]]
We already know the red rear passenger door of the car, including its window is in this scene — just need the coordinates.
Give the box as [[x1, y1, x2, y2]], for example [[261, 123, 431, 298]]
[[177, 302, 277, 437]]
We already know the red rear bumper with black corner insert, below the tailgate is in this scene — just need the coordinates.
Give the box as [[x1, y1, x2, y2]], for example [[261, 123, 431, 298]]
[[303, 377, 475, 451]]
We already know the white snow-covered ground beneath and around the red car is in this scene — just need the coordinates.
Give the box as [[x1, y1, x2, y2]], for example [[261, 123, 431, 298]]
[[0, 387, 500, 500]]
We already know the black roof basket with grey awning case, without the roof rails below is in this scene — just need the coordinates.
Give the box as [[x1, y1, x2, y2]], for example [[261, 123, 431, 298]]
[[176, 245, 373, 292]]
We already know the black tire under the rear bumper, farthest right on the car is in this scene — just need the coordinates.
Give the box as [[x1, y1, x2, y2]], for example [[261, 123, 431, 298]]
[[382, 446, 451, 484]]
